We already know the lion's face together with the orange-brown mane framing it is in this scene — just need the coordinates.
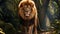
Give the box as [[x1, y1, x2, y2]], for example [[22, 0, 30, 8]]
[[19, 2, 35, 20]]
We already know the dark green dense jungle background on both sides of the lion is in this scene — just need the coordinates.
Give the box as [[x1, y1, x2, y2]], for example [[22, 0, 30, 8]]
[[0, 0, 60, 34]]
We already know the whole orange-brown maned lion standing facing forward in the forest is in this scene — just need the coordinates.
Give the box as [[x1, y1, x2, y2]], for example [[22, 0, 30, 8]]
[[18, 0, 38, 34]]
